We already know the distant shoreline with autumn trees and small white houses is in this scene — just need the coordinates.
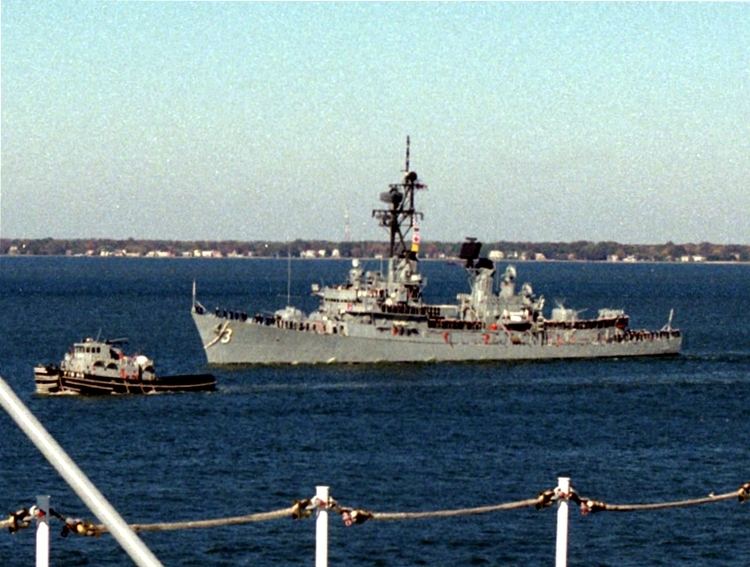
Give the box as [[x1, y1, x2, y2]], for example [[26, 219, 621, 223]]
[[0, 238, 750, 262]]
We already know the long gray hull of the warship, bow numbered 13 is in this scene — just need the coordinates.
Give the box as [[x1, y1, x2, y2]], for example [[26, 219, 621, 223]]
[[192, 310, 682, 365]]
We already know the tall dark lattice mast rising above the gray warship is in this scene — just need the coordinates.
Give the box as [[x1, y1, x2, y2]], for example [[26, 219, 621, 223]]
[[372, 136, 427, 260]]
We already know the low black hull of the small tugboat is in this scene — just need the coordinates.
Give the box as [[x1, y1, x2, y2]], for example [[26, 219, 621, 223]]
[[36, 373, 216, 396]]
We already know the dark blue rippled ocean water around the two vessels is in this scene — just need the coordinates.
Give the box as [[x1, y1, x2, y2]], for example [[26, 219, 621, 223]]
[[0, 257, 750, 566]]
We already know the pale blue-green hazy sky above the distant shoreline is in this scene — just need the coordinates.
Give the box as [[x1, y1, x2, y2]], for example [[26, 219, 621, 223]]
[[0, 0, 750, 244]]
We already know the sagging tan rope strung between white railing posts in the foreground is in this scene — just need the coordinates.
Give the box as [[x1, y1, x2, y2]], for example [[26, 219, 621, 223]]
[[5, 482, 750, 537]]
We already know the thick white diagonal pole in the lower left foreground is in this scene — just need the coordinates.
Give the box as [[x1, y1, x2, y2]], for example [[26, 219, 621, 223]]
[[0, 377, 161, 567]]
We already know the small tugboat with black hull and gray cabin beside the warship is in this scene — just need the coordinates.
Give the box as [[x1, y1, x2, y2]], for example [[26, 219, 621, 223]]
[[34, 338, 216, 395]]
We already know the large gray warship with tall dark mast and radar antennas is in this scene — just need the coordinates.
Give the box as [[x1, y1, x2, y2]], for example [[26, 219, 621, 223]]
[[191, 137, 682, 365]]
